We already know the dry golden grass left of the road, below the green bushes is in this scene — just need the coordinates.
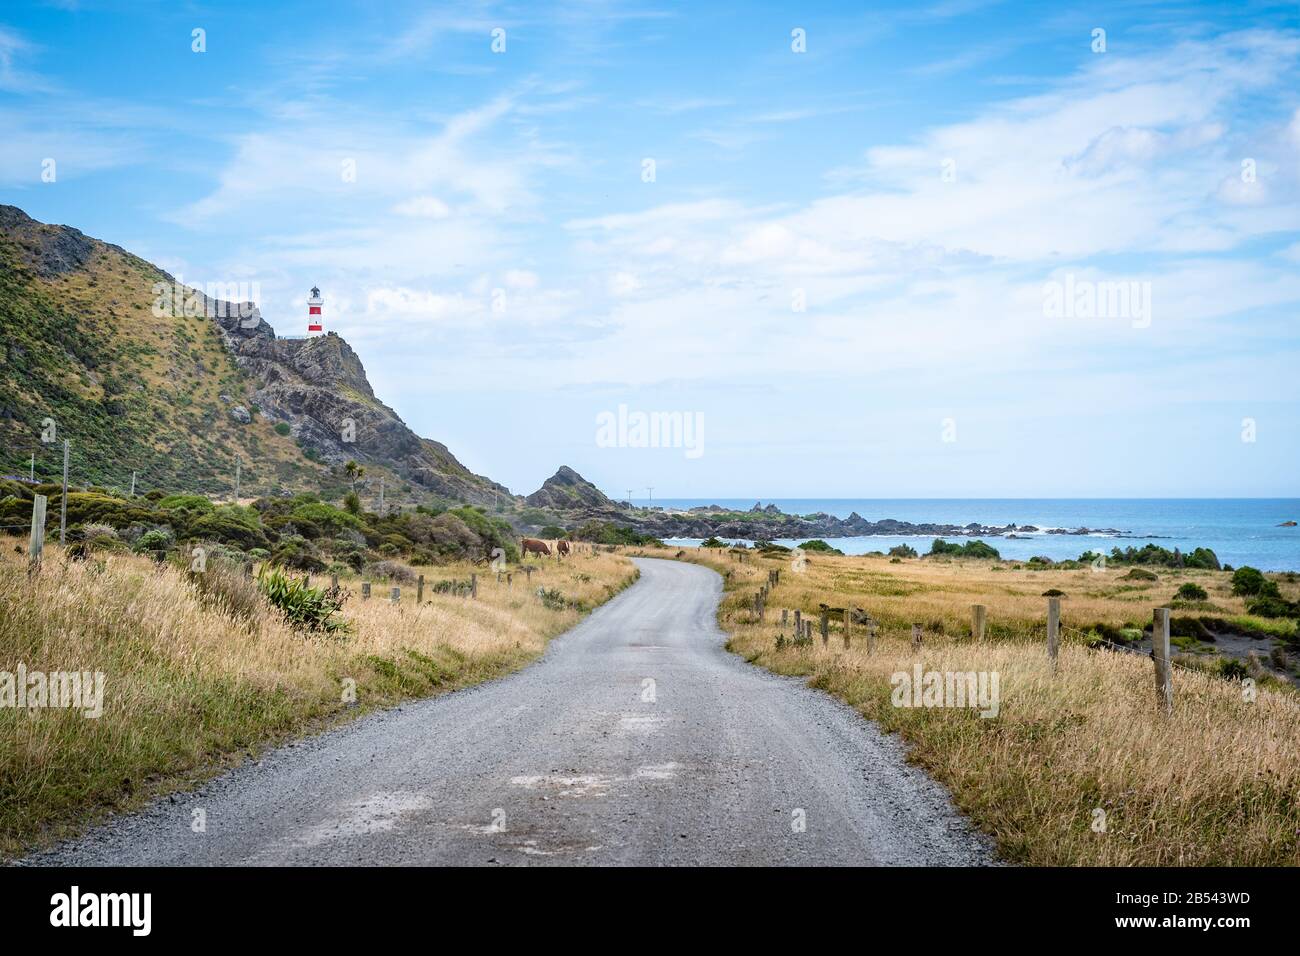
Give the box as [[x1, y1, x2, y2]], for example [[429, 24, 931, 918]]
[[0, 537, 636, 855]]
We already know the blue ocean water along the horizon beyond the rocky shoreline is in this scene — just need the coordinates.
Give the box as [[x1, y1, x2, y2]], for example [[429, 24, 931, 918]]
[[650, 498, 1300, 571]]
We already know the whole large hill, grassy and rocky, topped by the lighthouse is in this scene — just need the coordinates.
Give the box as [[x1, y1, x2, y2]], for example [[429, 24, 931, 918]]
[[0, 206, 515, 506]]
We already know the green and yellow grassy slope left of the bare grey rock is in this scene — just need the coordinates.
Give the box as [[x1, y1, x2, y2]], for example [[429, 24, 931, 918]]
[[0, 207, 325, 490]]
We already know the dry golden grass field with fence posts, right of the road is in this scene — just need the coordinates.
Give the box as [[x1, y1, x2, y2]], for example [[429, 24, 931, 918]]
[[650, 549, 1300, 866]]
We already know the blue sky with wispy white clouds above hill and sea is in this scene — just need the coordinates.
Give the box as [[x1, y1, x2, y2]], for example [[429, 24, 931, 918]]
[[0, 0, 1300, 498]]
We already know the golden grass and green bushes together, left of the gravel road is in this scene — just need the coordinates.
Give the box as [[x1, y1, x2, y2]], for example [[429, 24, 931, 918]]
[[0, 530, 636, 856]]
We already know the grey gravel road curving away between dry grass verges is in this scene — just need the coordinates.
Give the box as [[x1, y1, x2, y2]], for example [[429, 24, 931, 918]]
[[22, 559, 995, 866]]
